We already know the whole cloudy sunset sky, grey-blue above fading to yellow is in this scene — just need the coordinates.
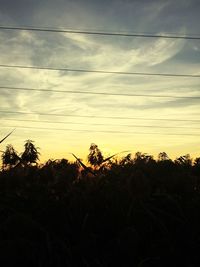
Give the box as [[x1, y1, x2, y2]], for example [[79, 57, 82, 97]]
[[0, 0, 200, 161]]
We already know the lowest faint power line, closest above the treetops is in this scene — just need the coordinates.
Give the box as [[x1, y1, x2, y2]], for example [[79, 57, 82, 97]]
[[1, 125, 200, 136]]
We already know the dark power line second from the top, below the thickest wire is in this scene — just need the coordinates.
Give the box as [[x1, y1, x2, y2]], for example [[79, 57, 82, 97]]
[[0, 64, 200, 78]]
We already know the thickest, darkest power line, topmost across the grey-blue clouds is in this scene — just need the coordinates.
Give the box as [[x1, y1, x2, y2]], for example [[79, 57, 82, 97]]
[[0, 25, 200, 40]]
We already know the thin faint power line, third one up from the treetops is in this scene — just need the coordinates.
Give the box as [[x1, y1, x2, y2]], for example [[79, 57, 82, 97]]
[[0, 110, 200, 122]]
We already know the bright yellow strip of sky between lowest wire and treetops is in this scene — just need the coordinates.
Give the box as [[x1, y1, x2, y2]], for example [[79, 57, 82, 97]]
[[1, 126, 199, 163]]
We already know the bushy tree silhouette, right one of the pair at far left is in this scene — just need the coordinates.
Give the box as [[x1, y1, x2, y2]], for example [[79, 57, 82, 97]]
[[21, 140, 40, 164]]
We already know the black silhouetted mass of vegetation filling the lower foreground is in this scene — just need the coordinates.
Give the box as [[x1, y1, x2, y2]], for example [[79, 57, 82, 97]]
[[0, 142, 200, 267]]
